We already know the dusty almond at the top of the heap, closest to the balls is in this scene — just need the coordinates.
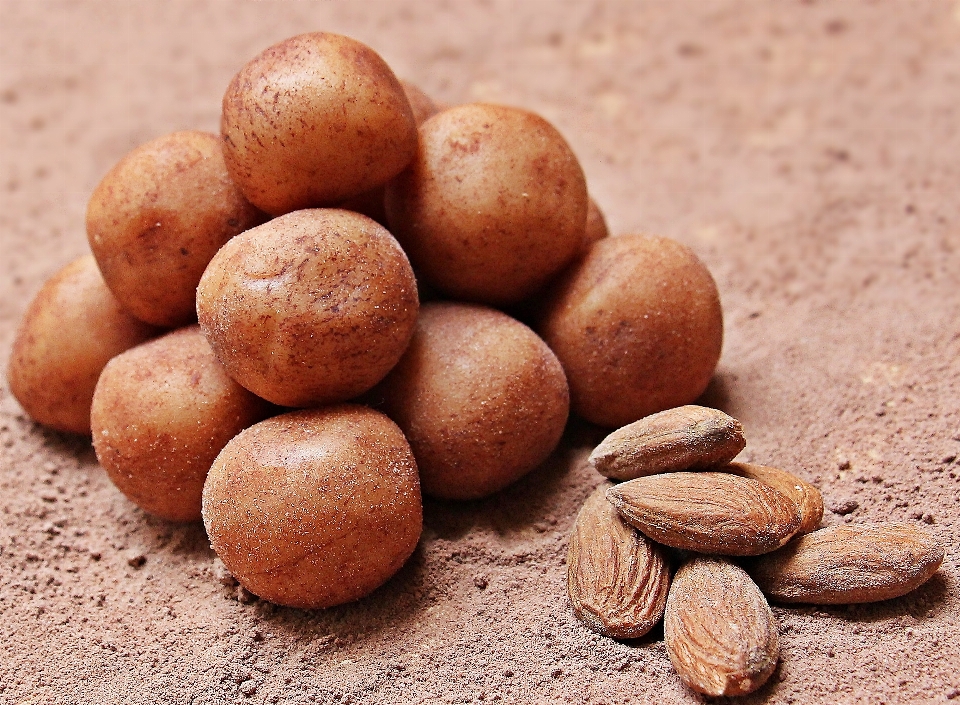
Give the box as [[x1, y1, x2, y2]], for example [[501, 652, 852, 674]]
[[589, 404, 746, 480]]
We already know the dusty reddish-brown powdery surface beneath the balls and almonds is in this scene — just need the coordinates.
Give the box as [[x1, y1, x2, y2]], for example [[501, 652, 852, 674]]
[[0, 0, 960, 704]]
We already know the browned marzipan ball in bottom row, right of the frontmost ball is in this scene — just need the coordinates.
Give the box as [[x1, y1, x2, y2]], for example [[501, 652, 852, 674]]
[[371, 303, 570, 499]]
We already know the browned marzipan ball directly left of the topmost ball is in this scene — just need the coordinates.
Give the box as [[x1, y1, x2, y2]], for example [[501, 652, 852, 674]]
[[87, 131, 264, 328]]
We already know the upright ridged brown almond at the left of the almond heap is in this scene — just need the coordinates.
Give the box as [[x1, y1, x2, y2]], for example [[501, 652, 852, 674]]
[[567, 482, 670, 639]]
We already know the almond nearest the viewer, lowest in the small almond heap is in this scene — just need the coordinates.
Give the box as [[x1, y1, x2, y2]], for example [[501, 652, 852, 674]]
[[663, 556, 780, 695]]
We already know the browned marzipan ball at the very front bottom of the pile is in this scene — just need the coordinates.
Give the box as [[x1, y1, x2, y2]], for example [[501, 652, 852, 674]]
[[203, 404, 423, 609]]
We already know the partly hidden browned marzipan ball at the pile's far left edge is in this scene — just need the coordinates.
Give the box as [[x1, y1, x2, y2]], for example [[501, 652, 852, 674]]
[[7, 255, 159, 434]]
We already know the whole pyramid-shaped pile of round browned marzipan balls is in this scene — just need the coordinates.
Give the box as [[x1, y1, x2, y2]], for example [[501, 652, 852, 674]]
[[9, 32, 723, 608]]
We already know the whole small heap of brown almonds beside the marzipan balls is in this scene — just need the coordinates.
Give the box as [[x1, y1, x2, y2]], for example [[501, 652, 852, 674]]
[[567, 406, 944, 696]]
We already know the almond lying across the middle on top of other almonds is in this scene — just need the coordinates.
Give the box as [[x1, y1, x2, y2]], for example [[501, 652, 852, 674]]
[[607, 472, 800, 556]]
